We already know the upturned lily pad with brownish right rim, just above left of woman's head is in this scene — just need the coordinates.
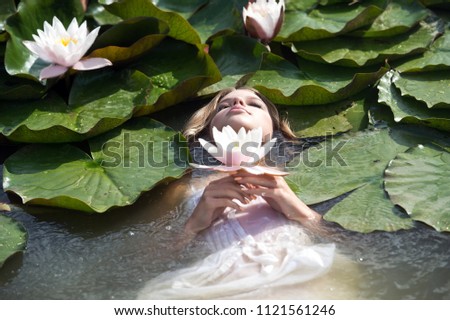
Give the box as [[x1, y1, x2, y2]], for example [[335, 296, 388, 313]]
[[132, 38, 221, 115]]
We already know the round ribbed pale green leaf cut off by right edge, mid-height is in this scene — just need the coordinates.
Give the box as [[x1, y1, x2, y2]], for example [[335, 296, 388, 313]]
[[384, 146, 450, 231]]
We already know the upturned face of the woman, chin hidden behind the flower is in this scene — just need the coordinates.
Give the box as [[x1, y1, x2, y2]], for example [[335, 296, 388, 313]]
[[210, 89, 273, 141]]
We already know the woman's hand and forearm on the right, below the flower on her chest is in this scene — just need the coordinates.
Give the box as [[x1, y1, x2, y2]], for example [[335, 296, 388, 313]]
[[233, 172, 321, 223]]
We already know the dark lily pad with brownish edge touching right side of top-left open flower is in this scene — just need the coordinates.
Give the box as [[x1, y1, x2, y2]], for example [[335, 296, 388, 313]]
[[89, 17, 169, 65]]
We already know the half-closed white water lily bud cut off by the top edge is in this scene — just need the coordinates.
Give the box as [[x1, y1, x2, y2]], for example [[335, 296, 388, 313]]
[[242, 0, 285, 44]]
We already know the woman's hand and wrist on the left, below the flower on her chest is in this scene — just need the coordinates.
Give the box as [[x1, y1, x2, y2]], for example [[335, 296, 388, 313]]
[[185, 176, 252, 234]]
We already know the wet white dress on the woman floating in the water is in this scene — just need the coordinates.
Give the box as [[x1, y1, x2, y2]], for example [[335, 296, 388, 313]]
[[137, 192, 335, 299]]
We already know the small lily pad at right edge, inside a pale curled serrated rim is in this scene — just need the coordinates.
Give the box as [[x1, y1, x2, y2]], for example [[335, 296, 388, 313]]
[[393, 71, 450, 109]]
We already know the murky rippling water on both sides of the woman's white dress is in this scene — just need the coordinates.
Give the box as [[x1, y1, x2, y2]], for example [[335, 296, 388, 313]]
[[0, 171, 450, 299]]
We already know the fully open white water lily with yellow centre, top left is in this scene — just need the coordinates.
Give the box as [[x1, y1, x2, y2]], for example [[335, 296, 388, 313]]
[[23, 17, 112, 80]]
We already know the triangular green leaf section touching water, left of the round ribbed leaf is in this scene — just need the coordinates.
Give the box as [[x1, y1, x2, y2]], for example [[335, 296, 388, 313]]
[[324, 180, 414, 233]]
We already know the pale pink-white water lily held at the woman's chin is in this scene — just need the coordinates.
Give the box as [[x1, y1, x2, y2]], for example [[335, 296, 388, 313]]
[[193, 126, 287, 175]]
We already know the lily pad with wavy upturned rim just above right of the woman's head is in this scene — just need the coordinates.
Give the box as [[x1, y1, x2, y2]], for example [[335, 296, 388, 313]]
[[246, 53, 387, 105]]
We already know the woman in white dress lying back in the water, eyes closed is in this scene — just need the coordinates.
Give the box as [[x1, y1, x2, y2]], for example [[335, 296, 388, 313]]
[[138, 88, 358, 299]]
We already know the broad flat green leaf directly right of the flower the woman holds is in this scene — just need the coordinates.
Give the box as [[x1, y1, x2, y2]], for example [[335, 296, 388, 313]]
[[289, 129, 408, 204]]
